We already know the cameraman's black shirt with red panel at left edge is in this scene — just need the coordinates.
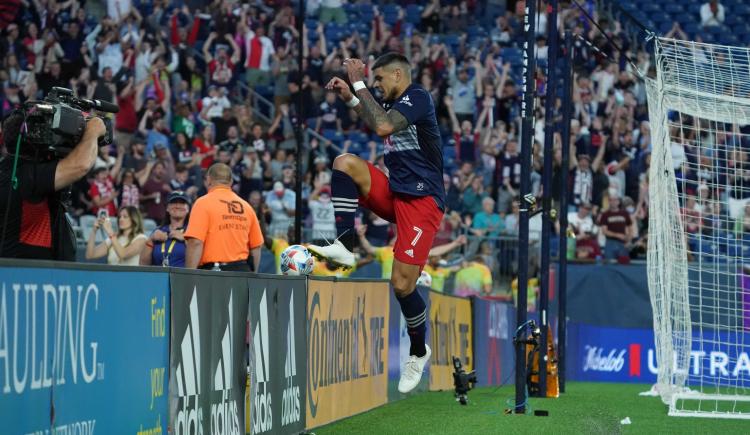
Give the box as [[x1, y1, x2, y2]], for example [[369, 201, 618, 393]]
[[0, 156, 65, 260]]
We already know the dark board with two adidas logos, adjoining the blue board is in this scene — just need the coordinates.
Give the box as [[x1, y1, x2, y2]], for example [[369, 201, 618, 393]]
[[169, 271, 248, 435]]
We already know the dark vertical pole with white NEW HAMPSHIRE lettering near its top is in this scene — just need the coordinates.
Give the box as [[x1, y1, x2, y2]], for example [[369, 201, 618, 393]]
[[515, 0, 536, 414]]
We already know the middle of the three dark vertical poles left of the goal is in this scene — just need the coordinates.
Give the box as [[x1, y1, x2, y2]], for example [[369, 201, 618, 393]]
[[539, 0, 562, 397]]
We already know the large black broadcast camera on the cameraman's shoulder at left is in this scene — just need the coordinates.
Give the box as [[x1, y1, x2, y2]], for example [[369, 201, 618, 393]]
[[23, 87, 119, 157]]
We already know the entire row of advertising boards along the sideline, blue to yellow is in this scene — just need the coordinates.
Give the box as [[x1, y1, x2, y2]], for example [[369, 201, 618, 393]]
[[0, 260, 528, 434]]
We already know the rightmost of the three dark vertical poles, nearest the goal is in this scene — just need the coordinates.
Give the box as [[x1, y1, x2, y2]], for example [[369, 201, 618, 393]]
[[557, 31, 573, 393]]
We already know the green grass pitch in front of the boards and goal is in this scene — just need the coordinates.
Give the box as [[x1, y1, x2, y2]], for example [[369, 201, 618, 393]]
[[312, 383, 750, 435]]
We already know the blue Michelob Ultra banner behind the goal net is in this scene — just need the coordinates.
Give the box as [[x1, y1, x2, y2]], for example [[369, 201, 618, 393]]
[[567, 323, 750, 388]]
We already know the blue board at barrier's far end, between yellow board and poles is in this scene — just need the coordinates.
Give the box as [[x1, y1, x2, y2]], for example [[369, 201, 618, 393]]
[[472, 298, 516, 385]]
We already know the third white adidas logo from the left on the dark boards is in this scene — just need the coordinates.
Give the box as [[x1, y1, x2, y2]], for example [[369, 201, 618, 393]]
[[253, 289, 273, 434]]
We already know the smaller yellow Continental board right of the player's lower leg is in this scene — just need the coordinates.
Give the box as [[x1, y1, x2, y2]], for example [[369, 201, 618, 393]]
[[429, 292, 474, 391]]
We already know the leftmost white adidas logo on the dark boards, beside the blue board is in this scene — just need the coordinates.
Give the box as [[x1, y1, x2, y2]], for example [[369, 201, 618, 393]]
[[174, 288, 204, 434]]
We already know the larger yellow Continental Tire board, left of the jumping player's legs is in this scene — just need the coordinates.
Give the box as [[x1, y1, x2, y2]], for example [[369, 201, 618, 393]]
[[306, 280, 390, 428]]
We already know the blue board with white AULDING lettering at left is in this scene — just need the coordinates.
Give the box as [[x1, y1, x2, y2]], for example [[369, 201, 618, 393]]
[[0, 268, 169, 434]]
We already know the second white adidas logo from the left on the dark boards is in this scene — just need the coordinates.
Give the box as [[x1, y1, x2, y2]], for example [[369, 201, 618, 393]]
[[211, 290, 240, 435]]
